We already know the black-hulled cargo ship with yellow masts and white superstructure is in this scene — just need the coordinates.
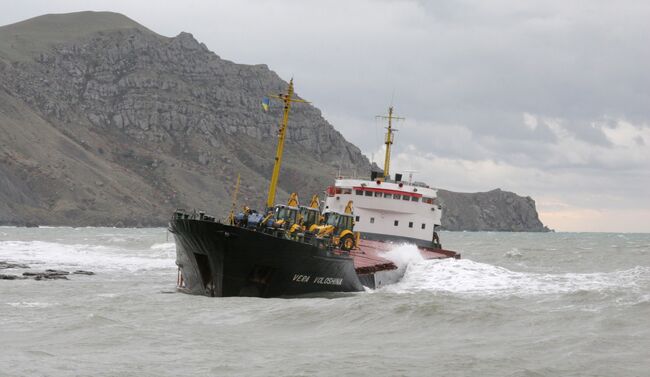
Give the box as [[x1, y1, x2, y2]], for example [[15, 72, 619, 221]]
[[169, 79, 460, 297]]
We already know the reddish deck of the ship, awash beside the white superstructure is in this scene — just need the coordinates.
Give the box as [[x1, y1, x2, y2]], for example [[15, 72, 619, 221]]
[[350, 239, 460, 274]]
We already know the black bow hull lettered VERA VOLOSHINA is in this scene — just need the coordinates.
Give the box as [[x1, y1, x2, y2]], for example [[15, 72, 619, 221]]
[[169, 218, 364, 297]]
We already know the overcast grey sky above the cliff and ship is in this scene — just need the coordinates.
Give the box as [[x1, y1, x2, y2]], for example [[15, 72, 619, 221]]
[[0, 0, 650, 232]]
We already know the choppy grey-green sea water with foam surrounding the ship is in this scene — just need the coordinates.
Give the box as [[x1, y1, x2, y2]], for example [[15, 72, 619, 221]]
[[0, 228, 650, 376]]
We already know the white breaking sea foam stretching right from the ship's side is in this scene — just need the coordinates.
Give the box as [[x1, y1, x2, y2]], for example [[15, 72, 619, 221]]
[[384, 253, 650, 296]]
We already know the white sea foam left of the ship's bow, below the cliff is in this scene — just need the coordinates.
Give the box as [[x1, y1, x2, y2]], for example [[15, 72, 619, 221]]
[[0, 241, 174, 272]]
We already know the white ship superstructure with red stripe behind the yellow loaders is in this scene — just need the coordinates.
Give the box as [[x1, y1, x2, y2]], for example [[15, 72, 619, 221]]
[[323, 178, 442, 244]]
